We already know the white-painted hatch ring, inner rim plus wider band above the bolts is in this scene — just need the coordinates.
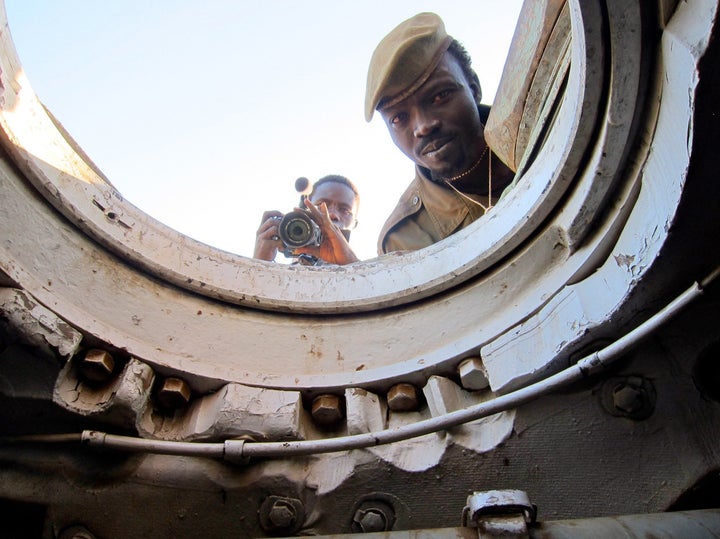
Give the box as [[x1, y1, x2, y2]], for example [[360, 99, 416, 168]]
[[0, 2, 660, 390]]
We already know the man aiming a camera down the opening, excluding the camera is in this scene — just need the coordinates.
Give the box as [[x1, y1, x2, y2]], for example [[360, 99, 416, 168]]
[[253, 174, 360, 265]]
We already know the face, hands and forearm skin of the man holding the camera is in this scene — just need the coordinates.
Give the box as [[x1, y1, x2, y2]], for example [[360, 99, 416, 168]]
[[253, 181, 358, 265]]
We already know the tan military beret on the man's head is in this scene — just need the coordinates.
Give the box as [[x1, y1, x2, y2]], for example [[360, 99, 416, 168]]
[[365, 13, 452, 122]]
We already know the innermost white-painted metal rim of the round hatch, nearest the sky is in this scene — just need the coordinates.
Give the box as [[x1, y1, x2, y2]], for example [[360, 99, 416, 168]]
[[0, 2, 604, 312]]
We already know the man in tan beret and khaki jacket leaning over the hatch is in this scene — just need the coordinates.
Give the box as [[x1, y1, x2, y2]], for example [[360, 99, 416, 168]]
[[365, 13, 513, 254]]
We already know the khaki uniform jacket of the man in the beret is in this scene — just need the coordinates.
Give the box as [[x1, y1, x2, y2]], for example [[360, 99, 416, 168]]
[[378, 166, 485, 254]]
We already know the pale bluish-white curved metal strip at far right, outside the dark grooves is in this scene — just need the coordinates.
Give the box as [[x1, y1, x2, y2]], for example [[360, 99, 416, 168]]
[[482, 1, 717, 389]]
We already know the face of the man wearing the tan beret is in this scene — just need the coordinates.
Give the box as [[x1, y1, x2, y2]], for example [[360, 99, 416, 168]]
[[381, 52, 484, 179]]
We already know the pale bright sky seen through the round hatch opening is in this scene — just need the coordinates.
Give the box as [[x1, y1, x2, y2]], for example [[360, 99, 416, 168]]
[[5, 0, 522, 262]]
